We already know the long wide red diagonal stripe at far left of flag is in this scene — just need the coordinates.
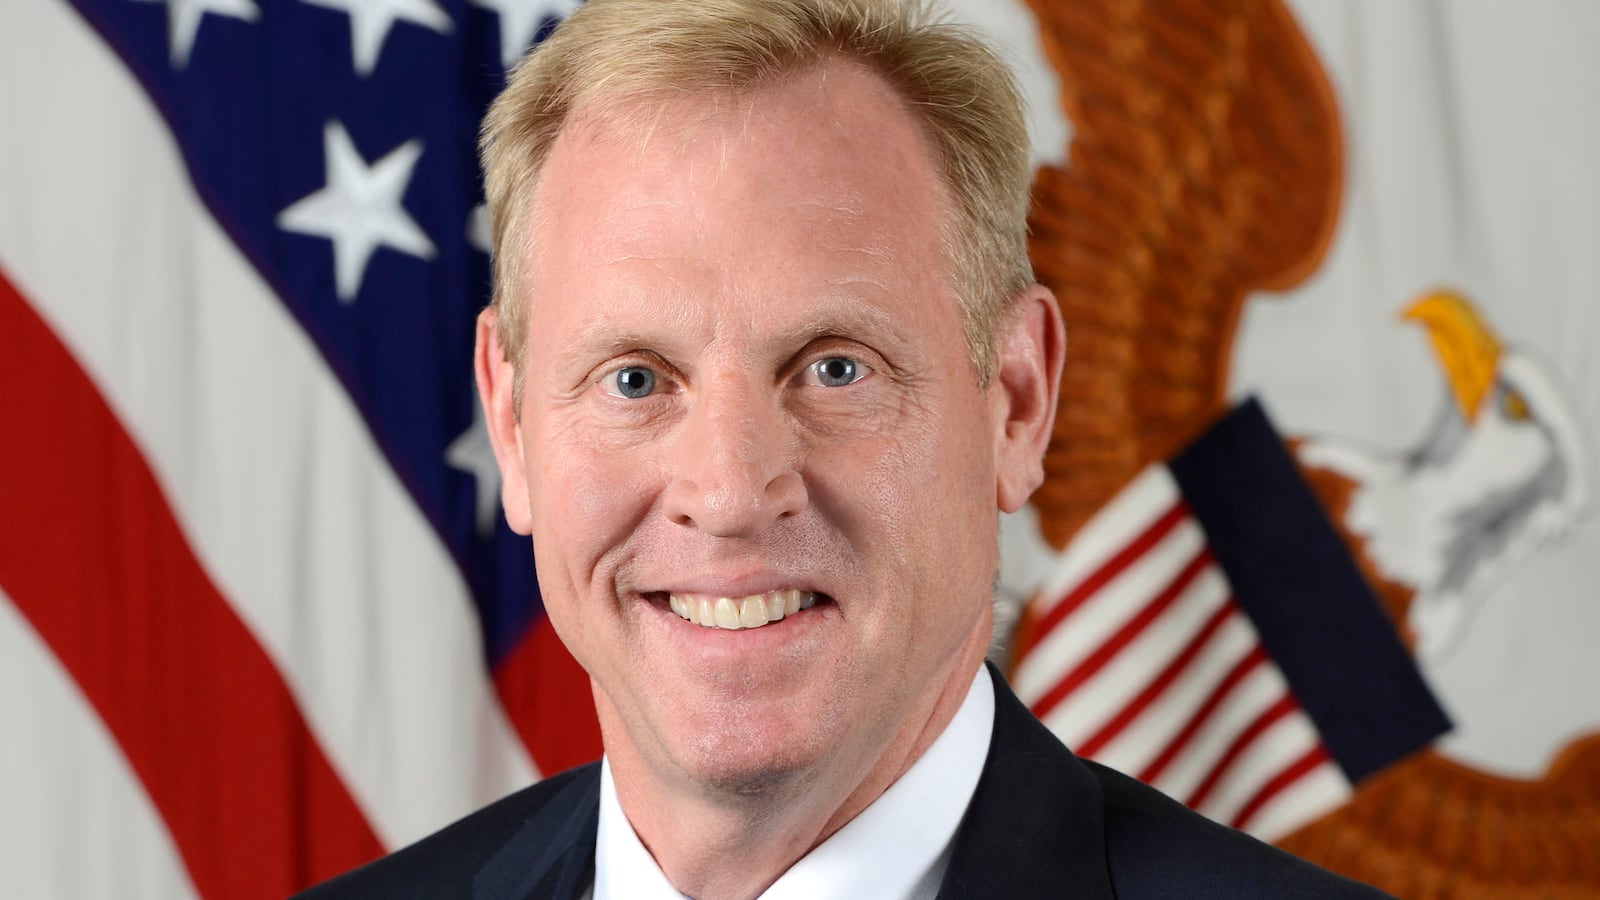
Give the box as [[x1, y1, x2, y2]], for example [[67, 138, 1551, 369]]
[[0, 272, 382, 900]]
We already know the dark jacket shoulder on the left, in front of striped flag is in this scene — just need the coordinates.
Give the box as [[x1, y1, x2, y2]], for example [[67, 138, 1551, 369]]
[[296, 764, 600, 900]]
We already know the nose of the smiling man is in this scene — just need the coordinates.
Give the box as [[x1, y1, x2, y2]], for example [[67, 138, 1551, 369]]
[[664, 386, 810, 536]]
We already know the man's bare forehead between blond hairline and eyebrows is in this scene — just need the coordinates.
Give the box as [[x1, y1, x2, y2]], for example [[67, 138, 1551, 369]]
[[522, 61, 949, 321]]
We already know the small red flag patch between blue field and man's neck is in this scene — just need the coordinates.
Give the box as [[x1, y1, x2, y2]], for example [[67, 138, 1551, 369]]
[[494, 615, 600, 775]]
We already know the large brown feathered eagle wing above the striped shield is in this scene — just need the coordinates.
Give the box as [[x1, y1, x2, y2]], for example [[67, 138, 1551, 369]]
[[1029, 0, 1341, 548]]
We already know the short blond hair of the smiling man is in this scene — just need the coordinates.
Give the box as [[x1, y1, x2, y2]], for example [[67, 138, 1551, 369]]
[[480, 0, 1034, 392]]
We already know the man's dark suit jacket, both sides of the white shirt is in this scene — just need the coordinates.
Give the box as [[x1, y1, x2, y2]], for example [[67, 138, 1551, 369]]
[[302, 671, 1384, 900]]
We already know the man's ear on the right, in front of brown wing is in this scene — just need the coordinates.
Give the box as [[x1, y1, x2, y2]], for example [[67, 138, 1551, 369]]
[[990, 285, 1067, 512]]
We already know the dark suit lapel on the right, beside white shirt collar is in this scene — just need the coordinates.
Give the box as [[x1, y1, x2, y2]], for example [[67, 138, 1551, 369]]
[[939, 666, 1114, 900]]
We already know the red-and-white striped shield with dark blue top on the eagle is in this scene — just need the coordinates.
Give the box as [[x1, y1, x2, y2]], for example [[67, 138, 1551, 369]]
[[1011, 402, 1450, 839]]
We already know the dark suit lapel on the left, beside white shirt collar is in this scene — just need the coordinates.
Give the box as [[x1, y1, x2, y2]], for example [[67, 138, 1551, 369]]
[[472, 764, 600, 900]]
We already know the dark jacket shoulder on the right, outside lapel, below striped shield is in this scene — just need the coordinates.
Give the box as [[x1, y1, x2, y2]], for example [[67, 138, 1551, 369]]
[[1078, 761, 1387, 898]]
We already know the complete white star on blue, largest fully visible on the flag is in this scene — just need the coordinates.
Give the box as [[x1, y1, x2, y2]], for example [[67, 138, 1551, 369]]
[[277, 122, 435, 303]]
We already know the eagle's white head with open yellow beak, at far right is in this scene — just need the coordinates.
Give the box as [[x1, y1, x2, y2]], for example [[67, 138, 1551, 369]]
[[1301, 293, 1592, 658]]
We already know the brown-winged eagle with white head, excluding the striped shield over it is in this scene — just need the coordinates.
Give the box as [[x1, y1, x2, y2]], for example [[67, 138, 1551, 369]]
[[992, 0, 1600, 897]]
